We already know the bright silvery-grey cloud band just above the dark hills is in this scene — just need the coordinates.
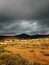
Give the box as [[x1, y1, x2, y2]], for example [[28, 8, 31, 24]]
[[0, 20, 49, 35]]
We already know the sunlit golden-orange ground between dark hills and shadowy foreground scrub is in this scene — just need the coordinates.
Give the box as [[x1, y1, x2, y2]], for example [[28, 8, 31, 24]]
[[0, 38, 49, 65]]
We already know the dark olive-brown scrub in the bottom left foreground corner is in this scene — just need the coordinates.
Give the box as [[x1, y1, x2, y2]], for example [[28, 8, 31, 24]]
[[0, 52, 32, 65]]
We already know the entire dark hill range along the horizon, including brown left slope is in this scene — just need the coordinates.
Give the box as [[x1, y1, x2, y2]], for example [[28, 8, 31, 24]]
[[0, 33, 49, 40]]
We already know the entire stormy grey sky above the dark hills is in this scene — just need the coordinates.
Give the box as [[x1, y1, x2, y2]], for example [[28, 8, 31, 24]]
[[0, 0, 49, 36]]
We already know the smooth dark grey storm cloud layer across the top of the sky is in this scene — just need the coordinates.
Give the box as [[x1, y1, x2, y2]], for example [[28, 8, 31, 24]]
[[0, 0, 49, 20]]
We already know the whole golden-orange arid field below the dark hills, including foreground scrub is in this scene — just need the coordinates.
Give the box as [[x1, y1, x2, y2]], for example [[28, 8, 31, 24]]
[[0, 38, 49, 65]]
